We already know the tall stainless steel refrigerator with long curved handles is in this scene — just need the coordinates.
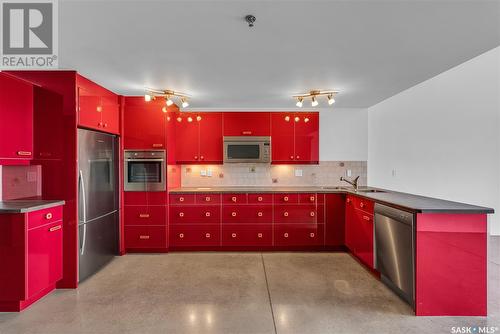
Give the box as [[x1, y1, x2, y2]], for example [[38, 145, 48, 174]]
[[78, 129, 118, 281]]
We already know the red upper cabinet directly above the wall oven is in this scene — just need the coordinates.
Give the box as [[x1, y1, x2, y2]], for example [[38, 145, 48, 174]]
[[123, 96, 177, 149]]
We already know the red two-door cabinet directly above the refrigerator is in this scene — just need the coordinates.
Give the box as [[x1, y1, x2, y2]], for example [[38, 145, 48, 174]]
[[76, 75, 120, 134]]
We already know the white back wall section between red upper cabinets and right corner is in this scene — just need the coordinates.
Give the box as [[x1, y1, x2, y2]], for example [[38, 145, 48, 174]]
[[319, 107, 368, 161]]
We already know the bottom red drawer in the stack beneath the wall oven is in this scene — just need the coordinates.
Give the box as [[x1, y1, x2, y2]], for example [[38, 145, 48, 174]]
[[125, 226, 167, 249]]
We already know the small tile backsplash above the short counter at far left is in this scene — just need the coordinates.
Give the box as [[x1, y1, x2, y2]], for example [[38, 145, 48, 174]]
[[0, 165, 42, 201]]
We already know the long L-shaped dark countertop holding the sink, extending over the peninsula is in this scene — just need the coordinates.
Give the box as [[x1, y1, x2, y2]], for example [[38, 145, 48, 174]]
[[170, 186, 494, 214]]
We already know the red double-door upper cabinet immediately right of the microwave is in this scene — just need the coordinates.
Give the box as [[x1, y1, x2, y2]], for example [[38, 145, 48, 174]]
[[271, 112, 319, 164]]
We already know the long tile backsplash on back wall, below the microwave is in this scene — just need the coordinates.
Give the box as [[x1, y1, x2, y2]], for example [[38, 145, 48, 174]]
[[181, 161, 367, 187]]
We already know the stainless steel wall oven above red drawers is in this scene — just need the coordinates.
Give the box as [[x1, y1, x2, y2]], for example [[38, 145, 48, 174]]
[[123, 150, 167, 191]]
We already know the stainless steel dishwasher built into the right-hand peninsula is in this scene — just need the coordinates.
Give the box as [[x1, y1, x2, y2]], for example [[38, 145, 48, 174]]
[[375, 203, 415, 307]]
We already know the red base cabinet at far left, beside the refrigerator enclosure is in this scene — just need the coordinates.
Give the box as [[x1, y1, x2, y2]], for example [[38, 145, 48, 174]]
[[0, 206, 63, 312]]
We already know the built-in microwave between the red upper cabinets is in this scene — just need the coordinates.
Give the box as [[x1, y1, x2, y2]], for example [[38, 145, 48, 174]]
[[224, 136, 271, 163]]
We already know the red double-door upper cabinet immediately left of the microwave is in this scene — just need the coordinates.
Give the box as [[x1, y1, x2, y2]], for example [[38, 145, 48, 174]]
[[175, 112, 222, 164]]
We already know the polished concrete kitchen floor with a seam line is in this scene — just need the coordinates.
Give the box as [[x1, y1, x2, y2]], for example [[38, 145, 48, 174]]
[[0, 238, 500, 334]]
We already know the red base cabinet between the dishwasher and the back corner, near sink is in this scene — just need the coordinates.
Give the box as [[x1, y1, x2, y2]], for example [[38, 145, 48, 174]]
[[345, 195, 374, 268]]
